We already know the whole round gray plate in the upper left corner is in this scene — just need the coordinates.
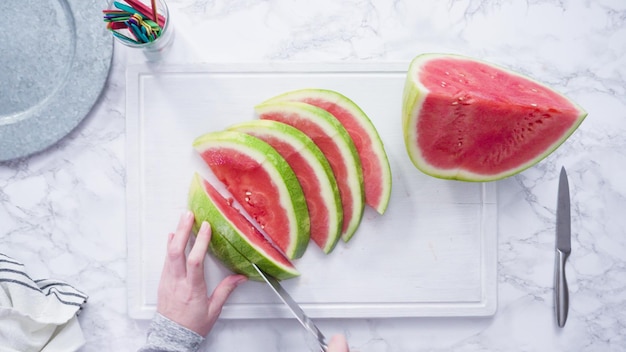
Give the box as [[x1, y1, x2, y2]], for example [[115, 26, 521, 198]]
[[0, 0, 113, 161]]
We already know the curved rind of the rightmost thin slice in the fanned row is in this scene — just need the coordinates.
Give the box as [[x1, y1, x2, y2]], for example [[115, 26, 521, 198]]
[[265, 88, 392, 214]]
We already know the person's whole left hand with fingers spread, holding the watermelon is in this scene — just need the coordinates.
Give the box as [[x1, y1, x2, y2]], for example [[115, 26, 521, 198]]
[[157, 211, 247, 336]]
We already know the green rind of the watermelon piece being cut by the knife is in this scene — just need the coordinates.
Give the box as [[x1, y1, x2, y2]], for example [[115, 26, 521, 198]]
[[188, 173, 300, 280]]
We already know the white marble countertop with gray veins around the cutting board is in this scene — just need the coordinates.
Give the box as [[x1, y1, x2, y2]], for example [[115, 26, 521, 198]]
[[0, 0, 626, 352]]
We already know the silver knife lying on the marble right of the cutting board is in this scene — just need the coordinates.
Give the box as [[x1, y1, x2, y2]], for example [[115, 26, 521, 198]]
[[554, 167, 572, 328]]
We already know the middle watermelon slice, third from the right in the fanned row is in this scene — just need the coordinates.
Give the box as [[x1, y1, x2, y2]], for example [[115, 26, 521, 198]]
[[228, 120, 343, 253]]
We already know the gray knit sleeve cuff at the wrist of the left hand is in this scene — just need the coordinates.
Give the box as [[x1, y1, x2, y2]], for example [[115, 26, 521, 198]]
[[139, 313, 204, 352]]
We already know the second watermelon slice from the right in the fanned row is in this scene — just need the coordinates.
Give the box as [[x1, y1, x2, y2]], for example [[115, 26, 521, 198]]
[[255, 102, 365, 242]]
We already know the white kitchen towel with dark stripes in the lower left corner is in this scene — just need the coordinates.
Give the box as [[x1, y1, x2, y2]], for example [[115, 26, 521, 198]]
[[0, 253, 87, 352]]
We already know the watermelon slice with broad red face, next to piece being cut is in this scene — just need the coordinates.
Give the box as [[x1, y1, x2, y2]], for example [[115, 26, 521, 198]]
[[193, 131, 310, 259]]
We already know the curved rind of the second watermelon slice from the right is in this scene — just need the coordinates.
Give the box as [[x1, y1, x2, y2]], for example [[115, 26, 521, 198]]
[[254, 101, 365, 242]]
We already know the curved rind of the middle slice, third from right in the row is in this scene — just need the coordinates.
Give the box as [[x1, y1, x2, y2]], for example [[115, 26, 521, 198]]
[[227, 120, 343, 254]]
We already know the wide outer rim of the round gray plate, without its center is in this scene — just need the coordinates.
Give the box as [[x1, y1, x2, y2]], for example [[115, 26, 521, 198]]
[[0, 0, 113, 163]]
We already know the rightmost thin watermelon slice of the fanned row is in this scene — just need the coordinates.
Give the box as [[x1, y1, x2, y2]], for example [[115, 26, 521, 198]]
[[266, 89, 391, 214]]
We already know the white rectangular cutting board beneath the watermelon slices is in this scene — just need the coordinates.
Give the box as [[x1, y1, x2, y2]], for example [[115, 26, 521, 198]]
[[126, 63, 497, 319]]
